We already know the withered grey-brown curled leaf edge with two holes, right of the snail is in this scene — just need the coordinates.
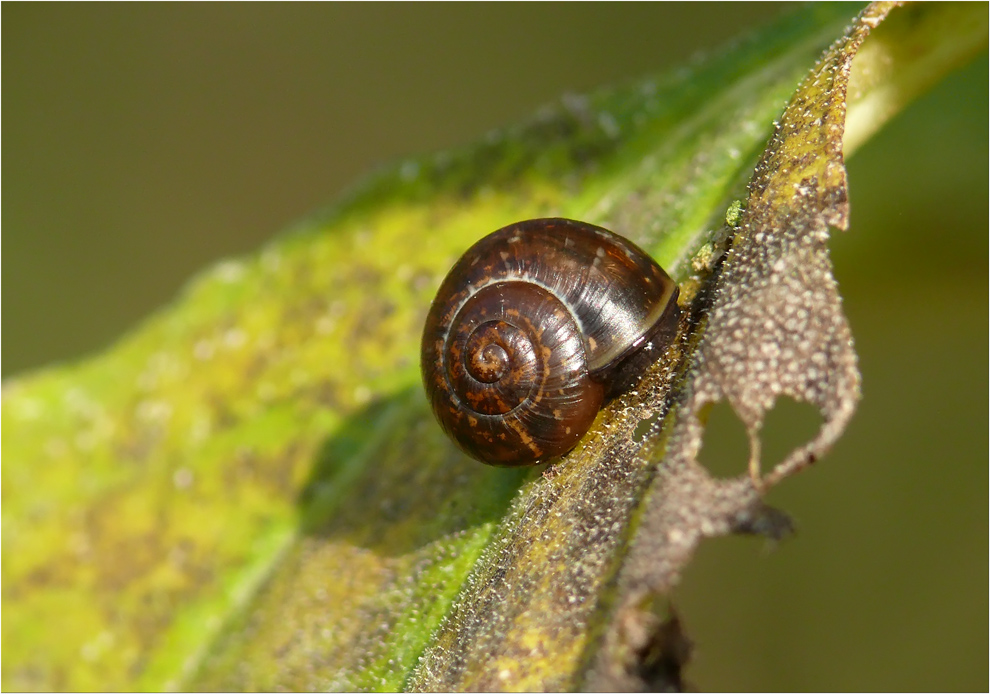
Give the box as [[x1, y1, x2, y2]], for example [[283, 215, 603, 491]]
[[589, 4, 891, 689]]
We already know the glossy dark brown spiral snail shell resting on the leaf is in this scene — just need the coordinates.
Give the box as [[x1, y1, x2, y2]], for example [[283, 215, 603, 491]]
[[422, 219, 679, 466]]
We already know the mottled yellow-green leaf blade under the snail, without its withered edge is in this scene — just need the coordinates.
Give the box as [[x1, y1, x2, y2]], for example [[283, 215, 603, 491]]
[[2, 5, 986, 689]]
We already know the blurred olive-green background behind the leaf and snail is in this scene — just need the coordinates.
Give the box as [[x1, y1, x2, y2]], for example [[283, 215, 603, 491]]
[[2, 3, 990, 690]]
